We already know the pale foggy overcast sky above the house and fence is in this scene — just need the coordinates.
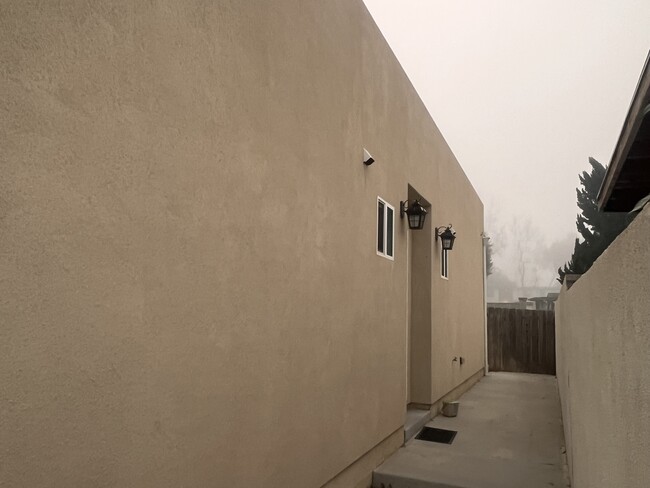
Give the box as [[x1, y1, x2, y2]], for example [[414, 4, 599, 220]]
[[365, 0, 650, 285]]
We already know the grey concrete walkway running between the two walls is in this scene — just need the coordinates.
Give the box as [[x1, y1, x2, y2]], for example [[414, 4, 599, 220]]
[[372, 373, 568, 488]]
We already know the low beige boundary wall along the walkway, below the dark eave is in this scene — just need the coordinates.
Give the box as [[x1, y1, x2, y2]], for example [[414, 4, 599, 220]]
[[555, 207, 650, 488]]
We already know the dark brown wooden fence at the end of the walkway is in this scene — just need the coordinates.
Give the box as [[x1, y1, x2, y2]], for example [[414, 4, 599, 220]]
[[488, 307, 555, 375]]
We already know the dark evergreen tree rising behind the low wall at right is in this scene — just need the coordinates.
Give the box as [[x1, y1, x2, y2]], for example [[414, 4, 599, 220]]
[[557, 158, 629, 283]]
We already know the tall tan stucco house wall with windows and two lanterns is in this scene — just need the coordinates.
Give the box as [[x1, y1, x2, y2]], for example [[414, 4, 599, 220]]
[[0, 0, 484, 488]]
